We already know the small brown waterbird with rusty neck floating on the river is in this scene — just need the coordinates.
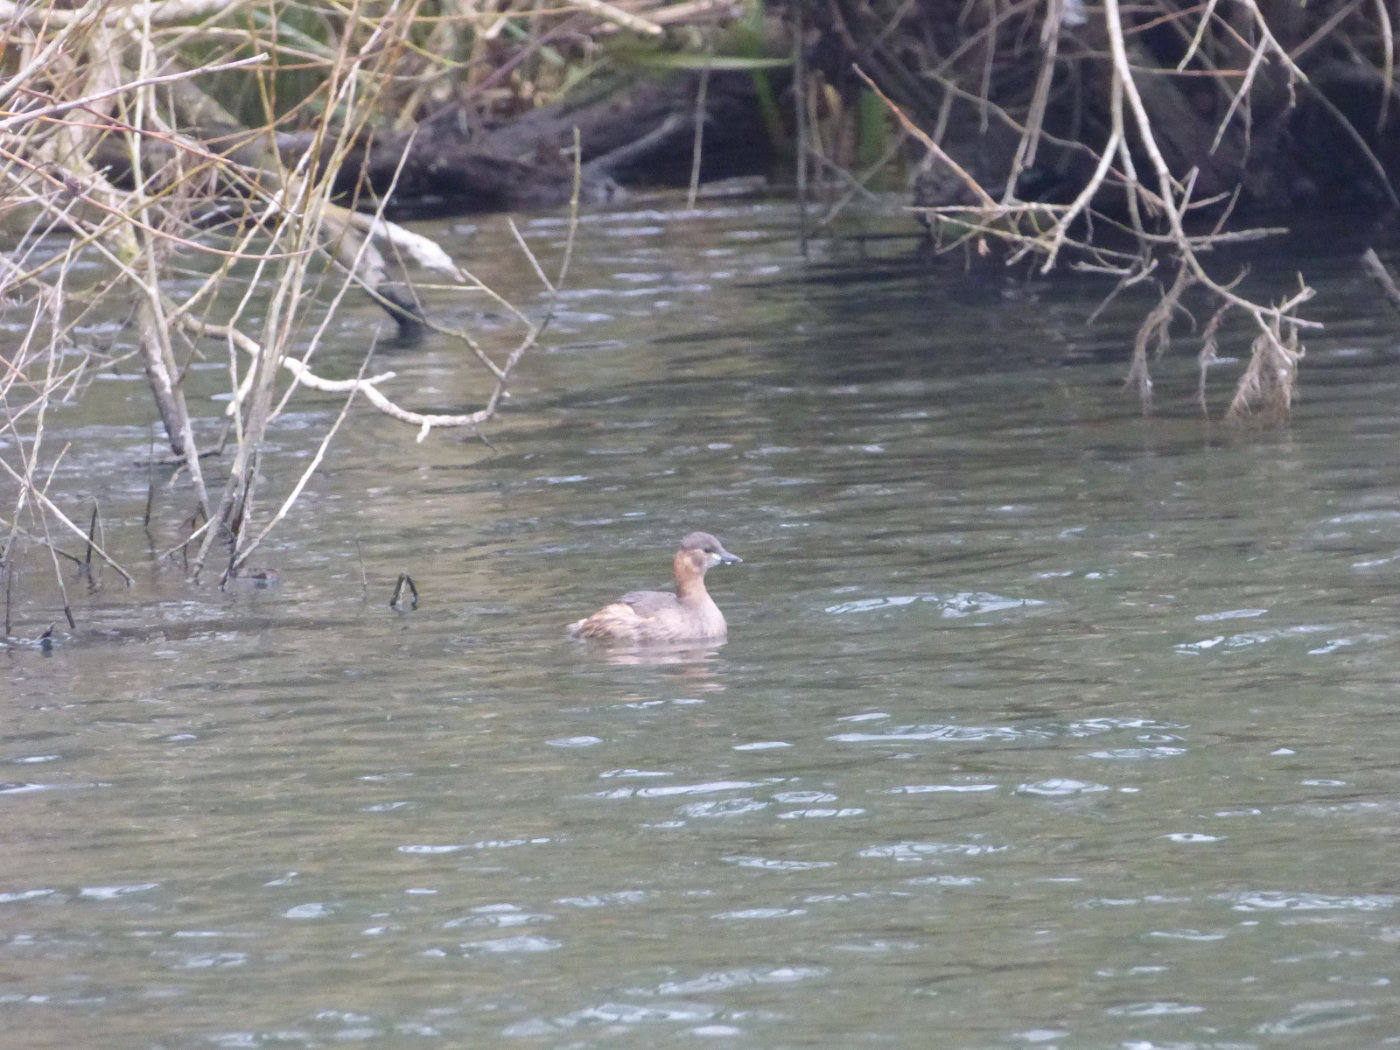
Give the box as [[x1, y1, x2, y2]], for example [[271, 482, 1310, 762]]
[[568, 532, 743, 643]]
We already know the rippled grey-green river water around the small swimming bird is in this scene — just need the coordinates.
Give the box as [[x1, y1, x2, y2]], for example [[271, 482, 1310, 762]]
[[0, 196, 1400, 1050]]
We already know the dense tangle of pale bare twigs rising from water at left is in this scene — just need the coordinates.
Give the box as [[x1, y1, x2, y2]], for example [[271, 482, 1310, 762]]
[[0, 0, 602, 637]]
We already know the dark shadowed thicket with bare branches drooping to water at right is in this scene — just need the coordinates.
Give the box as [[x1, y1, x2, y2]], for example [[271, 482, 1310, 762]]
[[790, 0, 1400, 420]]
